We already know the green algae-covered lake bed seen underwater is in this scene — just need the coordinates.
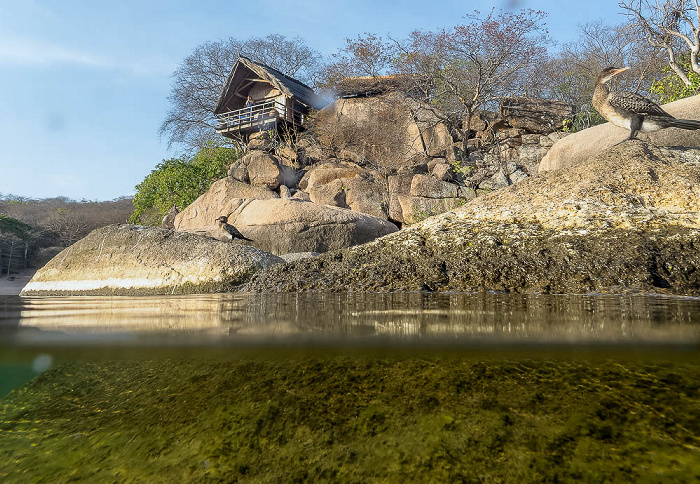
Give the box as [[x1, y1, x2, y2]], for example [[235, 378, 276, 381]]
[[0, 350, 700, 483]]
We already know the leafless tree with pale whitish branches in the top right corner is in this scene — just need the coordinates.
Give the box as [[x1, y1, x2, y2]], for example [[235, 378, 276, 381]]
[[620, 0, 700, 86]]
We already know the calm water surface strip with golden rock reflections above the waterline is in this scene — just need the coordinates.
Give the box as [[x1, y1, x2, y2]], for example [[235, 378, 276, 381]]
[[0, 293, 700, 344]]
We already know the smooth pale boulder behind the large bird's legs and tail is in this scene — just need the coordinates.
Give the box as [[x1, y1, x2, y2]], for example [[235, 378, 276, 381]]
[[539, 95, 700, 172]]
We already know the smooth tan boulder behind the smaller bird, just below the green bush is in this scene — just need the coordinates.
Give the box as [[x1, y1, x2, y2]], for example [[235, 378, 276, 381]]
[[174, 177, 279, 231]]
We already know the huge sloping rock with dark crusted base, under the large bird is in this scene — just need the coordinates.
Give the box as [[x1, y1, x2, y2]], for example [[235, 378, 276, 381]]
[[244, 141, 700, 295]]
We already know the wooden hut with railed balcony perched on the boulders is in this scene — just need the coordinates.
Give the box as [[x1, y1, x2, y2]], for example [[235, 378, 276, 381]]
[[214, 56, 326, 138]]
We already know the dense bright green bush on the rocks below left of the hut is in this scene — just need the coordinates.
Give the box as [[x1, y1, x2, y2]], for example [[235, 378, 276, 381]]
[[129, 146, 240, 225]]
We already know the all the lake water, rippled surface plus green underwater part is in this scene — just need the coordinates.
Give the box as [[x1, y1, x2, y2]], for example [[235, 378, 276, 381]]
[[0, 293, 700, 482]]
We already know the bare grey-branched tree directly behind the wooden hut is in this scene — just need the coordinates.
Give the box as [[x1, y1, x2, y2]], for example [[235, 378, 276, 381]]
[[159, 34, 321, 153]]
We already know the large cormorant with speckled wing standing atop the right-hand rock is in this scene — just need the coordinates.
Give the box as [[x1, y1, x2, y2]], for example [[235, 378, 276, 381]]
[[593, 67, 700, 144]]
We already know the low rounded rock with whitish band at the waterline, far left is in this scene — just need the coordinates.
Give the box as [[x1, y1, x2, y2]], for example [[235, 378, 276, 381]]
[[21, 225, 283, 296]]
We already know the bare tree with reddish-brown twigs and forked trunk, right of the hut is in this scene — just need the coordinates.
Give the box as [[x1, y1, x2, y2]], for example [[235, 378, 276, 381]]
[[401, 10, 550, 147]]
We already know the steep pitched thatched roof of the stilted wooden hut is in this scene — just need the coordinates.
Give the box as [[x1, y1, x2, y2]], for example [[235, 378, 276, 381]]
[[214, 56, 327, 114]]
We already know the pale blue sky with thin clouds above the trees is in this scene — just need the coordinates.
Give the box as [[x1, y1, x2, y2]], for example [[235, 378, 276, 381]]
[[0, 0, 623, 200]]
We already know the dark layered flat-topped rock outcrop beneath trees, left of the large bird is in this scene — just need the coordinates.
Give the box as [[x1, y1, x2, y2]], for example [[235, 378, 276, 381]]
[[498, 97, 574, 134]]
